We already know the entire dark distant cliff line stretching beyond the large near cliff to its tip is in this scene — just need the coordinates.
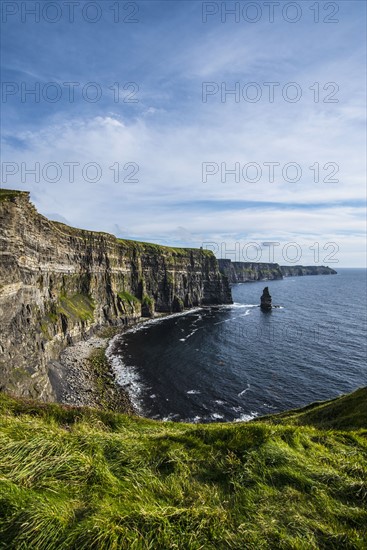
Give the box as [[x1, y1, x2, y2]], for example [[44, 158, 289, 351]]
[[218, 259, 336, 283]]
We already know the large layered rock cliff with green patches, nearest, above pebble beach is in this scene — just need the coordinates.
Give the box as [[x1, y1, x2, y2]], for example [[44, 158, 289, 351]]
[[0, 190, 232, 400]]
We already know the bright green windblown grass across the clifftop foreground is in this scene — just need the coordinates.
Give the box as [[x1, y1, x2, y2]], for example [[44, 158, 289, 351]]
[[0, 388, 367, 550]]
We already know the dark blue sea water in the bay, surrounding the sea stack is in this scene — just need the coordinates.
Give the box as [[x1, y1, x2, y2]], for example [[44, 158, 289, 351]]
[[110, 269, 367, 422]]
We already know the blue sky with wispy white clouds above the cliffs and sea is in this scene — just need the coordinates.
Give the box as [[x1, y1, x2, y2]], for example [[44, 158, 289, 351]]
[[1, 0, 366, 269]]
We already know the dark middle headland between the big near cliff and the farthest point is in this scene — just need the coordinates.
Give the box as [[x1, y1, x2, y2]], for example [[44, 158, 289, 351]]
[[218, 260, 283, 283]]
